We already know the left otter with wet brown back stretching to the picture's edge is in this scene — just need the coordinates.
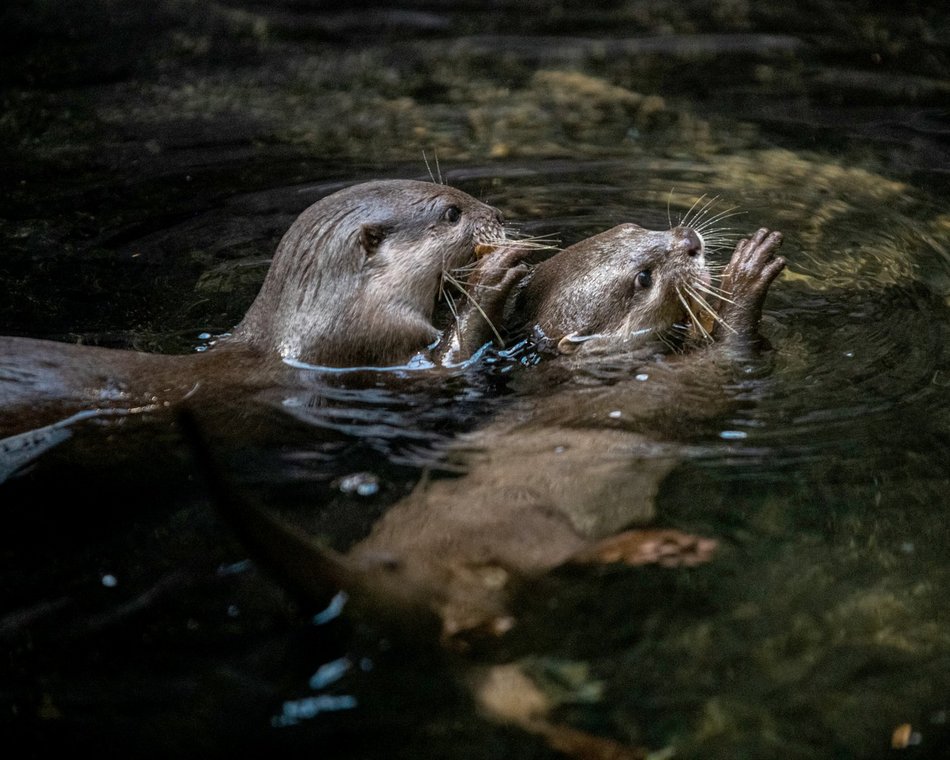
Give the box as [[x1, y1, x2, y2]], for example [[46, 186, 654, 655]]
[[0, 180, 520, 451]]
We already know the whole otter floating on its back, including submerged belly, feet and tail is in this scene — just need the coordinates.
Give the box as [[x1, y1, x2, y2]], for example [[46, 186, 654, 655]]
[[184, 217, 785, 760]]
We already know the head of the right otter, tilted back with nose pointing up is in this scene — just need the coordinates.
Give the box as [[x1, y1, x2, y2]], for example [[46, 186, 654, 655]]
[[518, 224, 710, 354]]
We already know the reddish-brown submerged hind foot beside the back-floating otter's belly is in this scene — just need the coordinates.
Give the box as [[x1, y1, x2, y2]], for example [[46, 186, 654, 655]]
[[574, 529, 718, 567]]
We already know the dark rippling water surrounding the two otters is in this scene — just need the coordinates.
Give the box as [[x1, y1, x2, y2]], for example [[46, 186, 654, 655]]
[[0, 2, 950, 758]]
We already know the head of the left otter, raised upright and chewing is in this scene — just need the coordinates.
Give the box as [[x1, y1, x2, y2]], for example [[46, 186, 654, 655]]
[[233, 180, 505, 366]]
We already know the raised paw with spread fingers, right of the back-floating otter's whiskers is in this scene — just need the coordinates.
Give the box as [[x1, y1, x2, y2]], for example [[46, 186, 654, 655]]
[[713, 228, 785, 338]]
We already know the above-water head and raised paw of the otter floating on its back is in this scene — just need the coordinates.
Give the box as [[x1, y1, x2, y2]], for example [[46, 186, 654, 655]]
[[509, 223, 785, 355]]
